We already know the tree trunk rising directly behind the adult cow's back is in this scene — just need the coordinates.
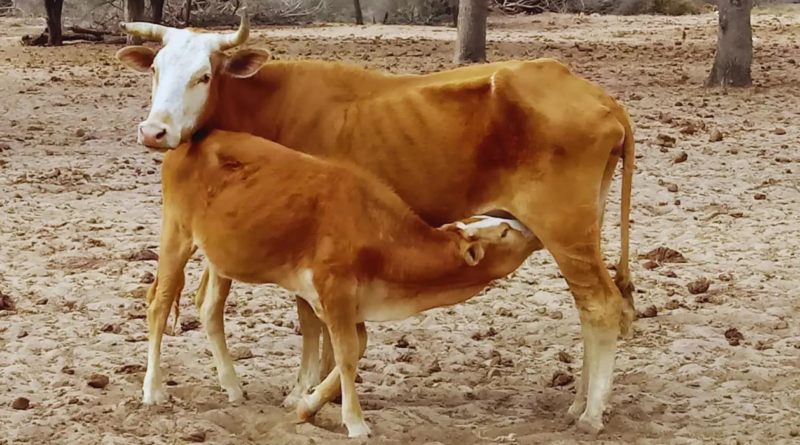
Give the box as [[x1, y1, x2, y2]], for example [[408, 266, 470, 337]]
[[453, 0, 488, 64]]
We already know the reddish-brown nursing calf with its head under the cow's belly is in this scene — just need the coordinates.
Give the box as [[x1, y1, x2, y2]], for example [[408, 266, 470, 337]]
[[148, 130, 539, 436]]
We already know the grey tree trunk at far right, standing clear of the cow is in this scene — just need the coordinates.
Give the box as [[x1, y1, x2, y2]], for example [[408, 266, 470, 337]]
[[706, 0, 753, 87]]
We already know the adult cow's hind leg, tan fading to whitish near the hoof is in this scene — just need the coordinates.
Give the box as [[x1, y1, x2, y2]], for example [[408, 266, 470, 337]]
[[512, 194, 623, 434]]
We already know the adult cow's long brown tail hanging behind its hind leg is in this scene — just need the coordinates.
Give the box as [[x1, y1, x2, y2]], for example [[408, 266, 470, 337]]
[[614, 113, 636, 336]]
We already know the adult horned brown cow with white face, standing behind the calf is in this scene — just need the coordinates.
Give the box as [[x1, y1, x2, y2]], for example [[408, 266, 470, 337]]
[[117, 17, 634, 433]]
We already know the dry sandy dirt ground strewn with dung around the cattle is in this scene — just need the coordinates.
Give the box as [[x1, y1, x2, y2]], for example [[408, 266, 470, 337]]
[[0, 9, 800, 445]]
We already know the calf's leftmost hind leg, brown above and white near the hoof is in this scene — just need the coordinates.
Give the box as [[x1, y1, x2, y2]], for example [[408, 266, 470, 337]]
[[142, 221, 194, 405]]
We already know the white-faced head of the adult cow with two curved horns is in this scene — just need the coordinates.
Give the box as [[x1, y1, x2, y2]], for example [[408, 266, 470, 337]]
[[116, 15, 270, 150]]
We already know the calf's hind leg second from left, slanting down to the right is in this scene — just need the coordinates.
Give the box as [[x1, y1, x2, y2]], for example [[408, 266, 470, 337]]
[[195, 264, 245, 402]]
